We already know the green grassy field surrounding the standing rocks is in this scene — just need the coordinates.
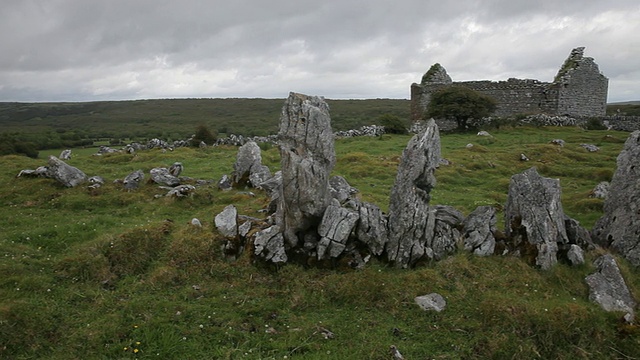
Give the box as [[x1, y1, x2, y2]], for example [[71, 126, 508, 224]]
[[0, 127, 640, 359]]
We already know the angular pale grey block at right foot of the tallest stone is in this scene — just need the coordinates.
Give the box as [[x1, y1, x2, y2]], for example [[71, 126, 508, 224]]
[[318, 199, 359, 260]]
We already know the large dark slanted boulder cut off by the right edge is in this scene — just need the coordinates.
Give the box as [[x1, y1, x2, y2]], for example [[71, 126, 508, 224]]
[[591, 131, 640, 266]]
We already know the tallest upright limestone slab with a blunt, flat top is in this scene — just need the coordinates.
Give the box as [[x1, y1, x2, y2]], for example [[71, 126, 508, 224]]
[[276, 93, 336, 247]]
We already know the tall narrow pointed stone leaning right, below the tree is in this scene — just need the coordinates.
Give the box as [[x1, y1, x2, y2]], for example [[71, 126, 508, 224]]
[[386, 120, 440, 267]]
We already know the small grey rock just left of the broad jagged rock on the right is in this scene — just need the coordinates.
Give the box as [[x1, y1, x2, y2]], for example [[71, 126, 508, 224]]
[[463, 206, 497, 256]]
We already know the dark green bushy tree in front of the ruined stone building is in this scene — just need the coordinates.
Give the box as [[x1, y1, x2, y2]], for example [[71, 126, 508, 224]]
[[426, 85, 497, 130]]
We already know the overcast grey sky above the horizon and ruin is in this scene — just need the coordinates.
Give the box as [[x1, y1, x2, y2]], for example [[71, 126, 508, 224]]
[[0, 0, 640, 102]]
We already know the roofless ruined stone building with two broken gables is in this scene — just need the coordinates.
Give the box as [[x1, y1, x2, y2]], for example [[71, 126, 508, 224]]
[[411, 47, 609, 121]]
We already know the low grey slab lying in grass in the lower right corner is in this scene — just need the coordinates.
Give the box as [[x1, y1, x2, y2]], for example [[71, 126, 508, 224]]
[[585, 254, 637, 318]]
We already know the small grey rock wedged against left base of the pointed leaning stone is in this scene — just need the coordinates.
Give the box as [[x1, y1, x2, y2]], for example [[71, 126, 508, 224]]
[[356, 202, 389, 255]]
